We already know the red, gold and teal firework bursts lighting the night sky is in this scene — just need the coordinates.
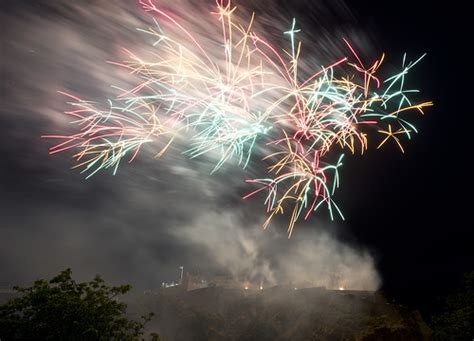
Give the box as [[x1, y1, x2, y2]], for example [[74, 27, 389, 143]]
[[46, 0, 432, 236]]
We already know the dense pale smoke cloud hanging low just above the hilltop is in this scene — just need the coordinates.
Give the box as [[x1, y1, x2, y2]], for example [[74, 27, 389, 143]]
[[173, 212, 380, 290]]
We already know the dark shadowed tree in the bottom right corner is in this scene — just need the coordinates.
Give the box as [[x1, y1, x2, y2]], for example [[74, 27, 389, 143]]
[[432, 271, 474, 340]]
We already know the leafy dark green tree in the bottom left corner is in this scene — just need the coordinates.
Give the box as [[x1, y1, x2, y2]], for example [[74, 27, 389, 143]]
[[0, 269, 157, 340]]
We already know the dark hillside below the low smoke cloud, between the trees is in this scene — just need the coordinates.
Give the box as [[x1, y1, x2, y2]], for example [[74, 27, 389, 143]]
[[130, 287, 431, 341]]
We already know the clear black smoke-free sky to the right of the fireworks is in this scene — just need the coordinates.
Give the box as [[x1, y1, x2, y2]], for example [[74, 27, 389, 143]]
[[338, 1, 474, 310]]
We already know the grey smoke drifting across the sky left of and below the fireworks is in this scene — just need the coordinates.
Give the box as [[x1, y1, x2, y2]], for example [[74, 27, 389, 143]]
[[0, 0, 379, 289]]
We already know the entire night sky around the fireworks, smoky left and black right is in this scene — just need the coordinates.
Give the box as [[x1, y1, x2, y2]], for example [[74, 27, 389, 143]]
[[0, 0, 474, 314]]
